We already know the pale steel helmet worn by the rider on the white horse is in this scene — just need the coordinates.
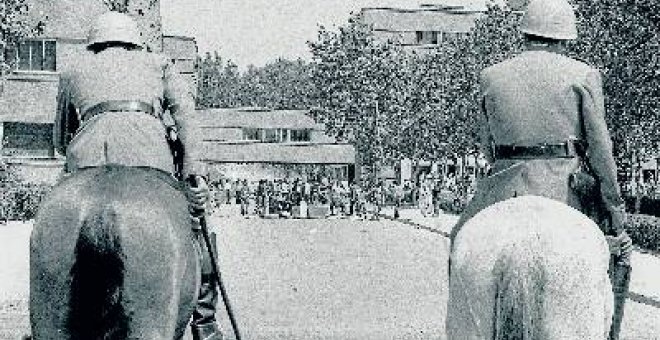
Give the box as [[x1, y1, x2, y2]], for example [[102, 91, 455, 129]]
[[520, 0, 577, 40]]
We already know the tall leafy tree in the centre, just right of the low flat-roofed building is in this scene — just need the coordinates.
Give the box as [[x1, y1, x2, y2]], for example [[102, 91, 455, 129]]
[[309, 15, 415, 181]]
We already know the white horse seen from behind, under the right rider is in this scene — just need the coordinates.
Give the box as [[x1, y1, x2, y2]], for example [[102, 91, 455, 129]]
[[446, 196, 613, 340]]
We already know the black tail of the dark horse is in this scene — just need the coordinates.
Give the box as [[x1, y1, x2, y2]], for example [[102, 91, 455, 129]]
[[67, 204, 129, 340]]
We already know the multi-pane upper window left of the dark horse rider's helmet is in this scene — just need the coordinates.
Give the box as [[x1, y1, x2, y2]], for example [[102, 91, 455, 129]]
[[16, 40, 57, 72]]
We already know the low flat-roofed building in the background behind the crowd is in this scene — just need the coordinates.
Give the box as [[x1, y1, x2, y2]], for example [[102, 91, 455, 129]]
[[197, 108, 355, 180]]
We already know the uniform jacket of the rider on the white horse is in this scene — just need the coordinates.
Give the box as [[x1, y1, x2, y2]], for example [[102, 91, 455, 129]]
[[453, 50, 623, 243]]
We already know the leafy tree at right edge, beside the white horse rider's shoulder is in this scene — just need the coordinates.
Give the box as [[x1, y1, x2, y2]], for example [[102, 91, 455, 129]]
[[571, 0, 660, 174]]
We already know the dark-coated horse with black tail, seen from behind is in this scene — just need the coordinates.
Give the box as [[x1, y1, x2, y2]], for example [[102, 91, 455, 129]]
[[30, 166, 200, 340]]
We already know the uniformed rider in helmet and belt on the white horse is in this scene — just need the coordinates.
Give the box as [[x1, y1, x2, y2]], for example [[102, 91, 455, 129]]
[[451, 0, 631, 339]]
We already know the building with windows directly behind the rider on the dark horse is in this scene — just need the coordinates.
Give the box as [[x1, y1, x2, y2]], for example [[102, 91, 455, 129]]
[[0, 0, 197, 182]]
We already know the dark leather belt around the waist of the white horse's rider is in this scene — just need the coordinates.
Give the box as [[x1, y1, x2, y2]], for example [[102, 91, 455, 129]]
[[493, 141, 580, 159]]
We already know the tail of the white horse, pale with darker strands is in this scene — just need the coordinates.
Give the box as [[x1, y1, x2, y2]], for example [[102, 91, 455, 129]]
[[492, 237, 547, 340]]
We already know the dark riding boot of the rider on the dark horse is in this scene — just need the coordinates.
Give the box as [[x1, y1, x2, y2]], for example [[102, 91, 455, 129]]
[[190, 233, 222, 340]]
